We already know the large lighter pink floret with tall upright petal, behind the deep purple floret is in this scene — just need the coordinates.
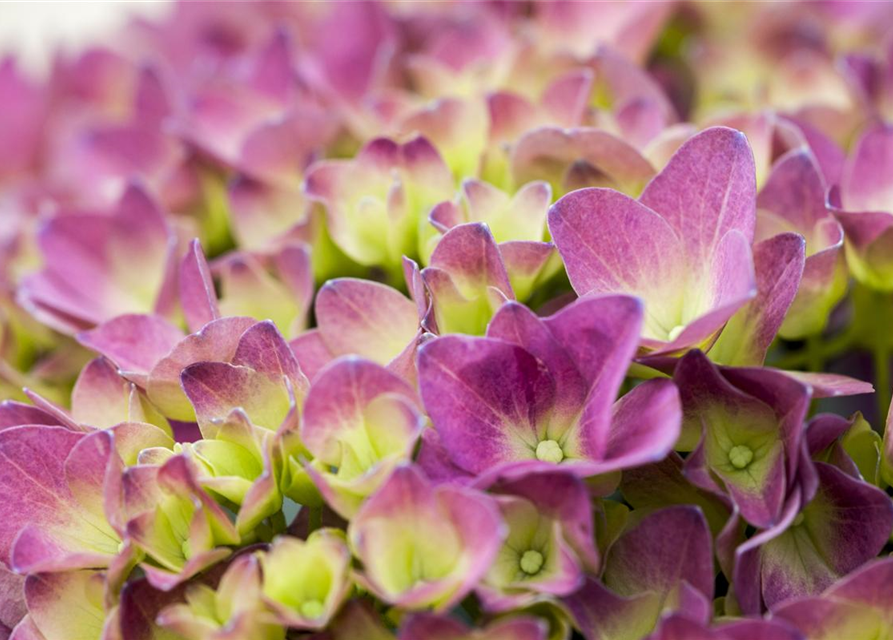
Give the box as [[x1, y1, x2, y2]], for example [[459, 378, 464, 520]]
[[549, 128, 756, 353]]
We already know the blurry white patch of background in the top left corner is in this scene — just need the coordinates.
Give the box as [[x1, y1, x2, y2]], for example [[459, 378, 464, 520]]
[[0, 0, 171, 74]]
